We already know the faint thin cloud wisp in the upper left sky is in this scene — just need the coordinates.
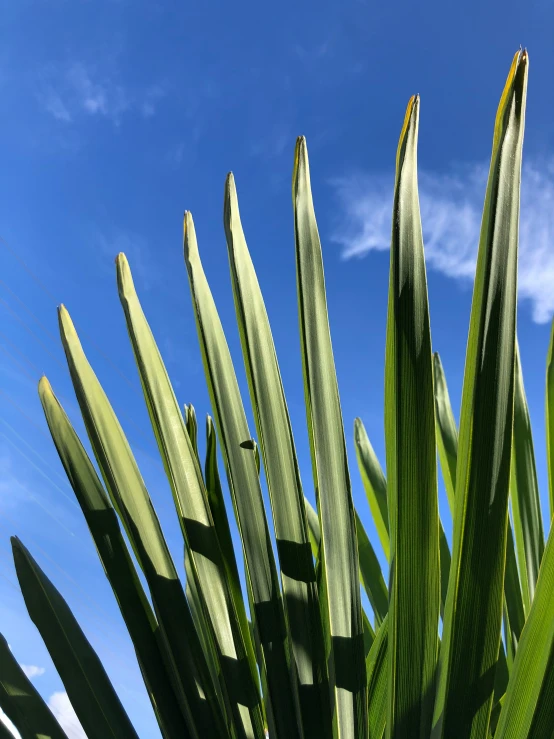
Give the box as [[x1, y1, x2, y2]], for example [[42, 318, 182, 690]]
[[38, 61, 166, 126]]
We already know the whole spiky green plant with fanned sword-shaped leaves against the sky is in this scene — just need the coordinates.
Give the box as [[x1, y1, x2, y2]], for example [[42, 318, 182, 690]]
[[0, 51, 554, 739]]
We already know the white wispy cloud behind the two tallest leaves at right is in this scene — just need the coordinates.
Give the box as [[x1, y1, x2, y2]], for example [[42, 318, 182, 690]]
[[332, 158, 554, 323]]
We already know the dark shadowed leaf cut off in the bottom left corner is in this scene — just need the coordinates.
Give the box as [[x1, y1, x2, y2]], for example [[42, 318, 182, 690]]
[[0, 634, 67, 739]]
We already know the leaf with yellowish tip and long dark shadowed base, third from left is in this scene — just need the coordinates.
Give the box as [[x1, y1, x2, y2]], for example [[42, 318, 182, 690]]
[[39, 377, 188, 739]]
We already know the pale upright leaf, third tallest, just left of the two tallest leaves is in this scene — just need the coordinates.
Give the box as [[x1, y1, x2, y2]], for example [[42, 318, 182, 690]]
[[293, 137, 367, 739]]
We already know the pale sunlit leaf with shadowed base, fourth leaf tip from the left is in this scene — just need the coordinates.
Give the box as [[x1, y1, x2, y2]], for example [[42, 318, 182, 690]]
[[59, 306, 228, 737]]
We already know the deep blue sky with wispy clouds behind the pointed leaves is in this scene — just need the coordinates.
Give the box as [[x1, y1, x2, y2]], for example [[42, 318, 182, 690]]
[[0, 0, 554, 739]]
